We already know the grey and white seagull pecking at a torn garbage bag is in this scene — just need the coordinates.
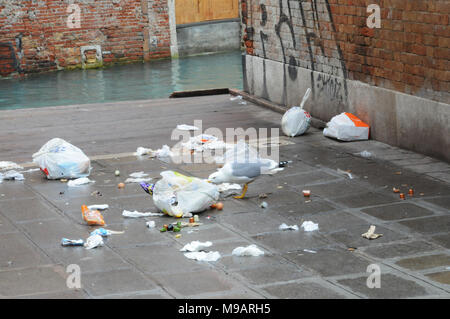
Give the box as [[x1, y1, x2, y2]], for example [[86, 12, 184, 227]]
[[208, 159, 288, 199]]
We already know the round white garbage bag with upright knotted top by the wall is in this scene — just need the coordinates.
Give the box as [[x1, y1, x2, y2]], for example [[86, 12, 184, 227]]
[[281, 89, 311, 137]]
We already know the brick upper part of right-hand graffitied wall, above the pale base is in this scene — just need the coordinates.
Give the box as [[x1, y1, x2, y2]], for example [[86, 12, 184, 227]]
[[241, 0, 450, 103]]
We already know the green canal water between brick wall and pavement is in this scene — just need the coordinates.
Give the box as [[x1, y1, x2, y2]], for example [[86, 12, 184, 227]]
[[0, 51, 243, 110]]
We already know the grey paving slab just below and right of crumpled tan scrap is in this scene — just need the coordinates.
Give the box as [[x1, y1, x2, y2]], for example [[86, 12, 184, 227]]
[[364, 241, 437, 258]]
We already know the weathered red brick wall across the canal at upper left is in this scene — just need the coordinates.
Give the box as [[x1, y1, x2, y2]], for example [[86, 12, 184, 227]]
[[0, 0, 170, 76]]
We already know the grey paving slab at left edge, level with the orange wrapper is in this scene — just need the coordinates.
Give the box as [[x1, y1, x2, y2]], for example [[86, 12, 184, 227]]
[[0, 198, 60, 221]]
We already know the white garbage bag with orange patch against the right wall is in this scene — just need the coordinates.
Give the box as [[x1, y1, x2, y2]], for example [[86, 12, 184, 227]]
[[323, 112, 370, 142]]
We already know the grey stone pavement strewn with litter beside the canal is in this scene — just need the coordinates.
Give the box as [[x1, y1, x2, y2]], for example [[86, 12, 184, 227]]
[[0, 95, 450, 299]]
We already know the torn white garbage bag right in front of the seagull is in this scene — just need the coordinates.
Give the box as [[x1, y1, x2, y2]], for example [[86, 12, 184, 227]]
[[153, 171, 219, 218]]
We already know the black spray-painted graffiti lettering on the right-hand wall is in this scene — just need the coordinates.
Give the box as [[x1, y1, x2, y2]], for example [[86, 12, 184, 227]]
[[260, 0, 348, 104]]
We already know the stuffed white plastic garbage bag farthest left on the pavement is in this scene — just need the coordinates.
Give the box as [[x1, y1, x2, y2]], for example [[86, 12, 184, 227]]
[[33, 138, 91, 179]]
